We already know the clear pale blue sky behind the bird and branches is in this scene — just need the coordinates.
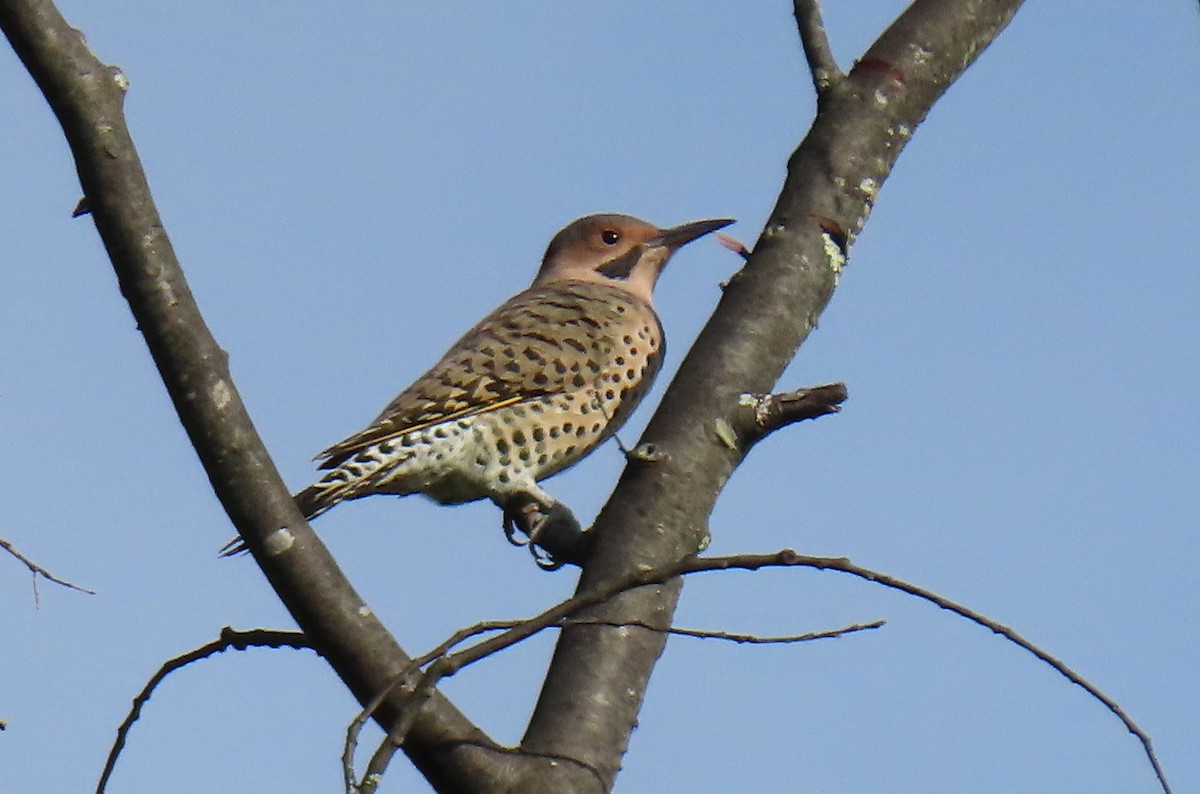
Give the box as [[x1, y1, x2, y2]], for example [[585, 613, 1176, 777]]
[[0, 0, 1200, 794]]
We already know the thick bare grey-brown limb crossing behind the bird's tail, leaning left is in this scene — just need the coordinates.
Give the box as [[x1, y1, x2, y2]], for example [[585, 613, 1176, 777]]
[[0, 0, 512, 790]]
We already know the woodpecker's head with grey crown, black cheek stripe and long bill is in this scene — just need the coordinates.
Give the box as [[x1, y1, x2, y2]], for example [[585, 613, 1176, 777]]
[[533, 215, 733, 305]]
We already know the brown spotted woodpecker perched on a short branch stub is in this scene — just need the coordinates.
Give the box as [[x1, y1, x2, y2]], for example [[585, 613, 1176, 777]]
[[224, 213, 733, 554]]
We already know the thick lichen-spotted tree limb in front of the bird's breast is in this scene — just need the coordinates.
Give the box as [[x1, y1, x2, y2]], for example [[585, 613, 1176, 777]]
[[522, 0, 1020, 792]]
